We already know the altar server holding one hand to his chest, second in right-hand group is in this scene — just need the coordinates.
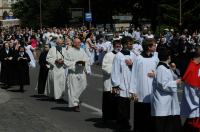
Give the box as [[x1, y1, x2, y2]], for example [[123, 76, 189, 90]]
[[111, 36, 136, 130]]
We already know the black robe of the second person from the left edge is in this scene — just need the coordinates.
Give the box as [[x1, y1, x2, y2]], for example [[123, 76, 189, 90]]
[[15, 52, 31, 85]]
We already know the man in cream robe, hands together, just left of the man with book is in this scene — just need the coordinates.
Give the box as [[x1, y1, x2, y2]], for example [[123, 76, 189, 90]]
[[45, 39, 66, 99]]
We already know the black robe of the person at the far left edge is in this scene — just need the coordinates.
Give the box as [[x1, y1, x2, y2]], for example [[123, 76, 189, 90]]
[[0, 48, 16, 85]]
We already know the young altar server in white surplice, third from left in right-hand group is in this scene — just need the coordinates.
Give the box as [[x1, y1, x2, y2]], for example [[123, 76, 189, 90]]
[[131, 39, 159, 132]]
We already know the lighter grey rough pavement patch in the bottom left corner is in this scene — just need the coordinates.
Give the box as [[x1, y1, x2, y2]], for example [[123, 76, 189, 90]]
[[0, 87, 61, 132]]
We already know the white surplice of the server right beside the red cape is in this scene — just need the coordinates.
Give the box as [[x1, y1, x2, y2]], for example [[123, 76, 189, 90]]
[[151, 65, 180, 116]]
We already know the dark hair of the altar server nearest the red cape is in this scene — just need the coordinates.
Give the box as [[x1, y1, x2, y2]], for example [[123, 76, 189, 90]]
[[157, 46, 170, 61]]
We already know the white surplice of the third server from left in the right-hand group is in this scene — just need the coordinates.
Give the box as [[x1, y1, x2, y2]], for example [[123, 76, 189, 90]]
[[131, 54, 159, 103]]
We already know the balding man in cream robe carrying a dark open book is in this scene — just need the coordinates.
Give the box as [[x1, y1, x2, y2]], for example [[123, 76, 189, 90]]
[[65, 38, 90, 112]]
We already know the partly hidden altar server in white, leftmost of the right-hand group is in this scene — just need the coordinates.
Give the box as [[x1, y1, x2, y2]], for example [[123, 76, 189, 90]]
[[102, 40, 121, 122]]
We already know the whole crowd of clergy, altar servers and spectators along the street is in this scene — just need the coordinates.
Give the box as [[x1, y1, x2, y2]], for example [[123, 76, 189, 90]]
[[0, 27, 200, 132]]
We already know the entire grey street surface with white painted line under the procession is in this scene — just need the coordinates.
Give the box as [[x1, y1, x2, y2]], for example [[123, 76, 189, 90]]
[[0, 65, 184, 132]]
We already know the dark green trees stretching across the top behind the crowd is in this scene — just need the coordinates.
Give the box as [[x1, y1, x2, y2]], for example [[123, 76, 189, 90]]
[[12, 0, 200, 31]]
